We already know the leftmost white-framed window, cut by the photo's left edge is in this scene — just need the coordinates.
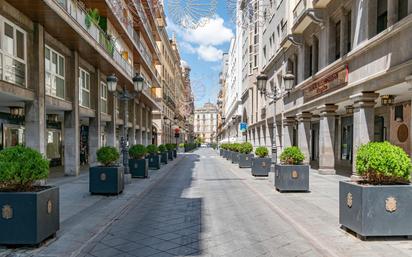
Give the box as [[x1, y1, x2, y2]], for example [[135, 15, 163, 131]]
[[0, 16, 26, 86]]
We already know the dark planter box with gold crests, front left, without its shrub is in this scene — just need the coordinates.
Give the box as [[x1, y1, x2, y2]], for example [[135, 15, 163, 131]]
[[0, 187, 60, 245]]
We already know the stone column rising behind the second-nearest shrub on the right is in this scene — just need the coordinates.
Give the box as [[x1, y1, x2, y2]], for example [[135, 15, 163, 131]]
[[297, 112, 312, 164]]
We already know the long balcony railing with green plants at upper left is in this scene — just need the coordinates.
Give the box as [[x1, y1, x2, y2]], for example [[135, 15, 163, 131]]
[[55, 0, 133, 76]]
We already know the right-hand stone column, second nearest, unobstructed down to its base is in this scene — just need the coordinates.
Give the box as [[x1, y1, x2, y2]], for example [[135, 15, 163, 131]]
[[319, 104, 338, 175]]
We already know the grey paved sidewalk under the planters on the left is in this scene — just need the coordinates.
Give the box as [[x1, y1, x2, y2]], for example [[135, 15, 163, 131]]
[[0, 154, 186, 257]]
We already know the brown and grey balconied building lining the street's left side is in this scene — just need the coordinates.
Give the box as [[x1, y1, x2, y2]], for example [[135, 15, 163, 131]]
[[0, 0, 189, 175]]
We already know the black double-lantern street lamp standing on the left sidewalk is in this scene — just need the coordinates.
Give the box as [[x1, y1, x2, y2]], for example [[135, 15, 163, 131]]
[[106, 73, 144, 179]]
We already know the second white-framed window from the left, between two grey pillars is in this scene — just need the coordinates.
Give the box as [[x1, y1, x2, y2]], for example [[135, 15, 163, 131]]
[[44, 46, 65, 99]]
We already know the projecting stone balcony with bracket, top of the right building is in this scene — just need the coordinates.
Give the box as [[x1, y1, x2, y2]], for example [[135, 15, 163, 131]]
[[292, 0, 322, 34]]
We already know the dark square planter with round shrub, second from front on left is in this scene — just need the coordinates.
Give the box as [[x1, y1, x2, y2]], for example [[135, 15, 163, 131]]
[[89, 146, 124, 195]]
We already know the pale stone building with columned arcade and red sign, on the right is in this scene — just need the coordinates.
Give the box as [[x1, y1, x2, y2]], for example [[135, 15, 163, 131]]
[[220, 0, 412, 175]]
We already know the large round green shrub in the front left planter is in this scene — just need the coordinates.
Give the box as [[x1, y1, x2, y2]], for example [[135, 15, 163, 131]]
[[0, 146, 49, 191]]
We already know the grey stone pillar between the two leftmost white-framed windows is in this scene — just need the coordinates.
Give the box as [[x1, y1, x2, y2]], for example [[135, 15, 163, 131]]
[[24, 23, 47, 155]]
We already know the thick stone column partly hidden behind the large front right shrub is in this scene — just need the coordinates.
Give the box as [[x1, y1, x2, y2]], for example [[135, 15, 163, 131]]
[[350, 92, 379, 179]]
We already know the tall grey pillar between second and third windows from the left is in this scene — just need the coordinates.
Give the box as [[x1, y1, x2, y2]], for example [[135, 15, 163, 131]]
[[64, 51, 80, 176]]
